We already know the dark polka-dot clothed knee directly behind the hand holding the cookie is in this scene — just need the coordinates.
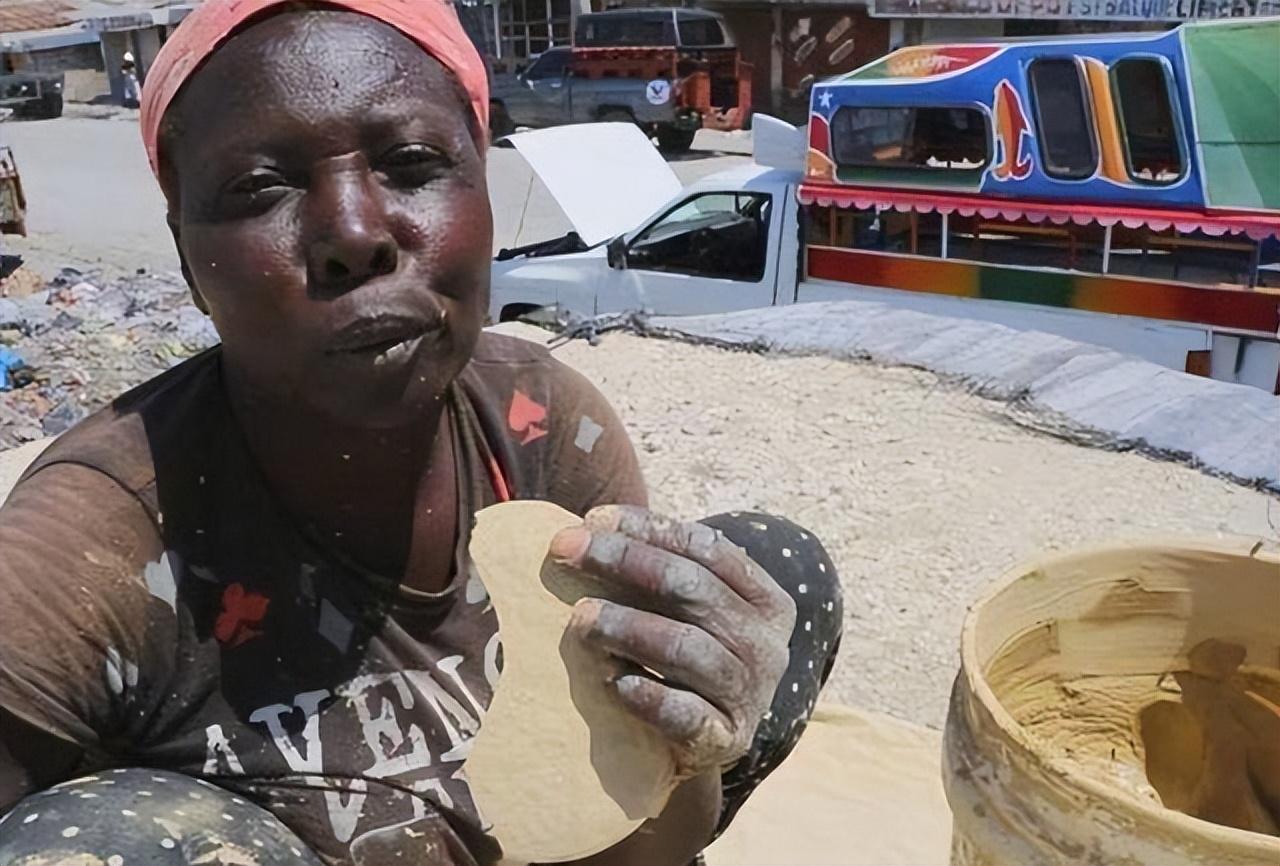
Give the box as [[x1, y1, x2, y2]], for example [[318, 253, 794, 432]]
[[701, 512, 844, 835]]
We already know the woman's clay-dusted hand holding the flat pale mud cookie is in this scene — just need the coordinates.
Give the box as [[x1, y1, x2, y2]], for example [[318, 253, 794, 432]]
[[552, 505, 796, 779]]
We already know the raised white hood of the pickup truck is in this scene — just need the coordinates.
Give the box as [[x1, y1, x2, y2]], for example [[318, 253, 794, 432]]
[[507, 123, 684, 247]]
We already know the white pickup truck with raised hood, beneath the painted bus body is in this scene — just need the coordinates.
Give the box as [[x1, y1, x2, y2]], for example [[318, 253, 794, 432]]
[[490, 115, 1280, 391]]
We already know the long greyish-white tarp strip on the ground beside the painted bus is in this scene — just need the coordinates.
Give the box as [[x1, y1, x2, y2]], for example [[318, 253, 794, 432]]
[[649, 301, 1280, 491]]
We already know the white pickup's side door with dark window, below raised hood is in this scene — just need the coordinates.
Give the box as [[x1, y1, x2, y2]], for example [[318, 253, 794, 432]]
[[599, 189, 785, 315]]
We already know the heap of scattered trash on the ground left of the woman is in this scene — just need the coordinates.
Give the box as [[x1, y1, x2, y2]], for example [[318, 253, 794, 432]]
[[0, 269, 218, 450]]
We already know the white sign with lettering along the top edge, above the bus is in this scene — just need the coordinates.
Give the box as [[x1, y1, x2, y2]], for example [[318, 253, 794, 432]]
[[870, 0, 1280, 22]]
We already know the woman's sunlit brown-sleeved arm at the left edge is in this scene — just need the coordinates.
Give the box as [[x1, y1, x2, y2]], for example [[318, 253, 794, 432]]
[[0, 463, 161, 814]]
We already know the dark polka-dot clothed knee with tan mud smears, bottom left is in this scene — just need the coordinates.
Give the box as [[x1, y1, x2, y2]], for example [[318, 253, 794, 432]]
[[0, 769, 320, 866]]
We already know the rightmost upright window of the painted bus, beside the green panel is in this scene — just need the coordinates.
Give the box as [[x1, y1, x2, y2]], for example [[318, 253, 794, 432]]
[[1111, 58, 1183, 183]]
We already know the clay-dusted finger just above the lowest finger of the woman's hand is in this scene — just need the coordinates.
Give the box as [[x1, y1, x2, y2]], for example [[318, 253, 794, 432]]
[[570, 599, 751, 724]]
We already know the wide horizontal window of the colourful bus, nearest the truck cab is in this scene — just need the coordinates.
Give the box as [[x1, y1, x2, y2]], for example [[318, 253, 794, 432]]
[[831, 106, 989, 177]]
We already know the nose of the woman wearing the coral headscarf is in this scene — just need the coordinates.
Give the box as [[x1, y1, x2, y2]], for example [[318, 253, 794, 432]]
[[307, 165, 399, 295]]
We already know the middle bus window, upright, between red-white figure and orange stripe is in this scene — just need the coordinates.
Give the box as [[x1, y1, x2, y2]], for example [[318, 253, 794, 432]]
[[1028, 58, 1098, 180]]
